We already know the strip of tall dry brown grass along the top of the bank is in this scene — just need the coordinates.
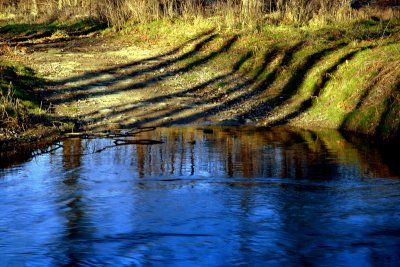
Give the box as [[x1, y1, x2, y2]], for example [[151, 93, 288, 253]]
[[0, 0, 400, 28]]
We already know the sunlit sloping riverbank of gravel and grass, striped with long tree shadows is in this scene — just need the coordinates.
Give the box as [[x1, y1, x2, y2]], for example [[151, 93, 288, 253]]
[[3, 18, 400, 144]]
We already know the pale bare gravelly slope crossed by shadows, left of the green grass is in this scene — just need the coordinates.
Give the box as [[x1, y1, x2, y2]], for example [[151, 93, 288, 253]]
[[15, 32, 264, 131]]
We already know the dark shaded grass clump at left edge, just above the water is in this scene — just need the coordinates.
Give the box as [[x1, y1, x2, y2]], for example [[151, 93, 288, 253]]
[[0, 60, 73, 142]]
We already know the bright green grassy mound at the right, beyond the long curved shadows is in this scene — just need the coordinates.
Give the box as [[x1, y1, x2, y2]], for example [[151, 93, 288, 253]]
[[297, 43, 400, 138]]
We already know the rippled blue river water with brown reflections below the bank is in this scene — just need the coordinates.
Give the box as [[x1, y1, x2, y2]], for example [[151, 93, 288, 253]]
[[0, 128, 400, 266]]
